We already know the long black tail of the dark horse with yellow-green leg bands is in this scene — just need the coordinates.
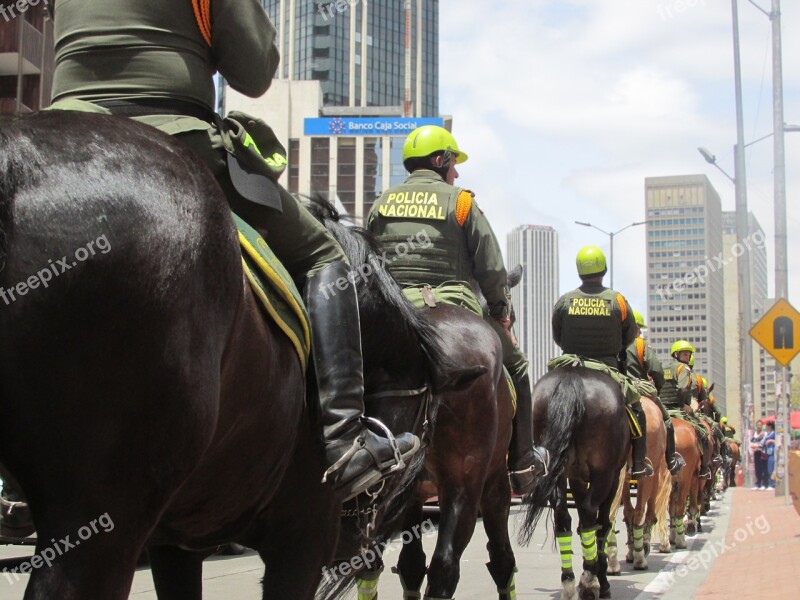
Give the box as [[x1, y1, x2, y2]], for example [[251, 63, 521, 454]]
[[519, 369, 586, 545]]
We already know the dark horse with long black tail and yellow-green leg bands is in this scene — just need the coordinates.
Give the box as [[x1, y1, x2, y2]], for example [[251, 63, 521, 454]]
[[520, 367, 630, 598]]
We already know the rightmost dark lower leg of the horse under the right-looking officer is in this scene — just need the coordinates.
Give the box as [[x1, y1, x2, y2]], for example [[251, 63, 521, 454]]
[[481, 456, 517, 600]]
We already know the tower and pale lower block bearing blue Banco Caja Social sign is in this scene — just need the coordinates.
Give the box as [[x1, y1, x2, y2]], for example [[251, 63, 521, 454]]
[[228, 0, 450, 224]]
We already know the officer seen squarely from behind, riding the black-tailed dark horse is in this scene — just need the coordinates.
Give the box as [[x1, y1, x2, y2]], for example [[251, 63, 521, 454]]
[[553, 246, 653, 477]]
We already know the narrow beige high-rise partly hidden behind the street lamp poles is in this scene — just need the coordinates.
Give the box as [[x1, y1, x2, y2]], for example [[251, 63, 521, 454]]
[[722, 211, 775, 431]]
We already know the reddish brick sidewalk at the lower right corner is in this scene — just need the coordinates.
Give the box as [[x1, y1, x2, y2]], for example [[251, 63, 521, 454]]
[[695, 488, 800, 599]]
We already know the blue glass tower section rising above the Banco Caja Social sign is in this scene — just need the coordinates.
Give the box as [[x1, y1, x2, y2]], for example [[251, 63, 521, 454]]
[[262, 0, 439, 116]]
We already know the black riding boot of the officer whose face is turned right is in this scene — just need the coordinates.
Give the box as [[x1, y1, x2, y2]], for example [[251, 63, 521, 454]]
[[508, 372, 550, 496]]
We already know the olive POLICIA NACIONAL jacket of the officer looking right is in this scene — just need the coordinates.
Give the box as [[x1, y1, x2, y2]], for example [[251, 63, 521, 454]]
[[367, 169, 511, 318]]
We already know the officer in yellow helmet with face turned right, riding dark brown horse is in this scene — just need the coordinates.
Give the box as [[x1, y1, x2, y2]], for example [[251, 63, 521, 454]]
[[367, 125, 548, 494]]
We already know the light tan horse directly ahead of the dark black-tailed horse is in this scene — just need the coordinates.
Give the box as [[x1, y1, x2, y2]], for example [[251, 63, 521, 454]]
[[608, 397, 672, 575]]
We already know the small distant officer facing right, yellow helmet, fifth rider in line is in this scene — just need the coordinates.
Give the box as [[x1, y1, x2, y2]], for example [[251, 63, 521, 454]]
[[661, 340, 711, 479]]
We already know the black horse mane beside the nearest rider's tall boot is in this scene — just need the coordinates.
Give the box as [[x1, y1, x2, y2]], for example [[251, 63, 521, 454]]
[[301, 196, 459, 387]]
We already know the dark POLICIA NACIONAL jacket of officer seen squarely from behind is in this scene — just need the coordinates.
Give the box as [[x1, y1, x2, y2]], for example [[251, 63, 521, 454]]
[[553, 283, 636, 368]]
